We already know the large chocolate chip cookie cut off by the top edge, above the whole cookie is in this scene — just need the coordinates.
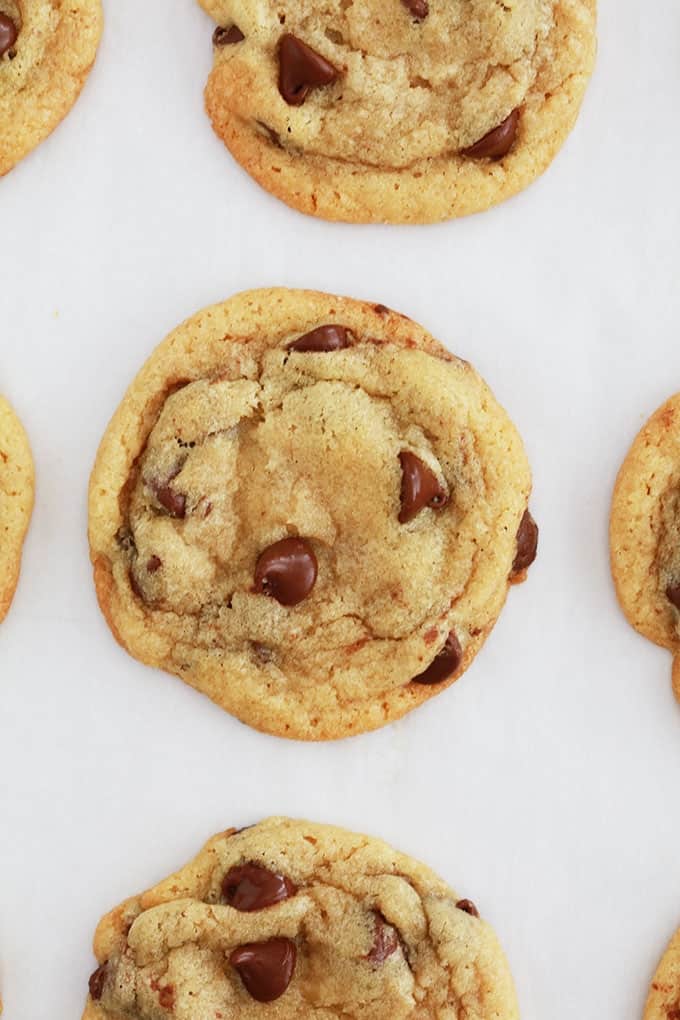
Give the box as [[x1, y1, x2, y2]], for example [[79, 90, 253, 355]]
[[200, 0, 595, 223]]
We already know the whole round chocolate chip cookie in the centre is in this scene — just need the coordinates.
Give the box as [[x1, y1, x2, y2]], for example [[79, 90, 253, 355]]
[[90, 290, 537, 740]]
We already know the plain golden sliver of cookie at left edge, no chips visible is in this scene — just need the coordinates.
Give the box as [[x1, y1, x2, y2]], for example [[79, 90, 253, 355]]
[[0, 397, 34, 623]]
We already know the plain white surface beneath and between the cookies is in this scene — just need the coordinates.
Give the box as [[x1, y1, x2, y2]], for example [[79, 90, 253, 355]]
[[0, 0, 680, 1020]]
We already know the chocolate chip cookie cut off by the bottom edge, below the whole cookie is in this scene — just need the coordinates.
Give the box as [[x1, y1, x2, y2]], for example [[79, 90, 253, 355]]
[[84, 818, 519, 1020]]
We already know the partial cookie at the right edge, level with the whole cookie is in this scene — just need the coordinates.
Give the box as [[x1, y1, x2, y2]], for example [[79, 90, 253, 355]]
[[610, 394, 680, 700]]
